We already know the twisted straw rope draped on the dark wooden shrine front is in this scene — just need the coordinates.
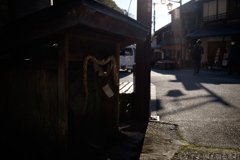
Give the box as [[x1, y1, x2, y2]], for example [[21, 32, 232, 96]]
[[83, 56, 118, 112]]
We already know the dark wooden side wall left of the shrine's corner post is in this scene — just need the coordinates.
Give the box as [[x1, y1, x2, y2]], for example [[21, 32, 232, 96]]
[[1, 67, 58, 158]]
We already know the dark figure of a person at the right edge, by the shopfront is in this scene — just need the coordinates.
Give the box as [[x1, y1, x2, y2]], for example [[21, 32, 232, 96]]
[[228, 39, 240, 75]]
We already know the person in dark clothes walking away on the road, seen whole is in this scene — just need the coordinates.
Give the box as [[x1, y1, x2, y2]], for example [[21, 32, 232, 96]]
[[193, 39, 204, 75]]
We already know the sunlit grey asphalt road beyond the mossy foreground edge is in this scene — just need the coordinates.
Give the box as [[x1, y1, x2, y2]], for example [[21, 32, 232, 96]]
[[152, 69, 240, 150]]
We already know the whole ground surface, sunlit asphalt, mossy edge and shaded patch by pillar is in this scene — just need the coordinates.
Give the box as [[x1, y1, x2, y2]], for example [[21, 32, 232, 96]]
[[102, 69, 240, 160]]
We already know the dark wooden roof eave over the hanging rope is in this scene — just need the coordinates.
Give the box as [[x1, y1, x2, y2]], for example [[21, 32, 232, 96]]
[[0, 0, 149, 52]]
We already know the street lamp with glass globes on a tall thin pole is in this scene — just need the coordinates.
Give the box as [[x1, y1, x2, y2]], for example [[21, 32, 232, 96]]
[[161, 0, 183, 66]]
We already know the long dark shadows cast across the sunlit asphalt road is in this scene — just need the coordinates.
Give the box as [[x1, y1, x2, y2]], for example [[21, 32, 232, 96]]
[[152, 69, 240, 117]]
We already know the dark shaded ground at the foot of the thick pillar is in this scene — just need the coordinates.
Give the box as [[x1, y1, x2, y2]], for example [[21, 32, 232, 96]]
[[94, 119, 148, 160]]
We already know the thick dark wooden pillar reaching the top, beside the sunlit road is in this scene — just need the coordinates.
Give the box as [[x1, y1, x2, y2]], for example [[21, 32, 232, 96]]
[[135, 0, 152, 121]]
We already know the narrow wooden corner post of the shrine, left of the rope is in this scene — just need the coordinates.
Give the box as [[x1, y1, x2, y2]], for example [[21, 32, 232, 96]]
[[58, 36, 69, 156]]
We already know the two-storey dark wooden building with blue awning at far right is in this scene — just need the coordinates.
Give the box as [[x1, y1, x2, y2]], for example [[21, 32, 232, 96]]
[[187, 0, 240, 68]]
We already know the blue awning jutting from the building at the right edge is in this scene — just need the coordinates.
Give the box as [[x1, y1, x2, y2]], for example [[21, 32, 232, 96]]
[[186, 24, 240, 37]]
